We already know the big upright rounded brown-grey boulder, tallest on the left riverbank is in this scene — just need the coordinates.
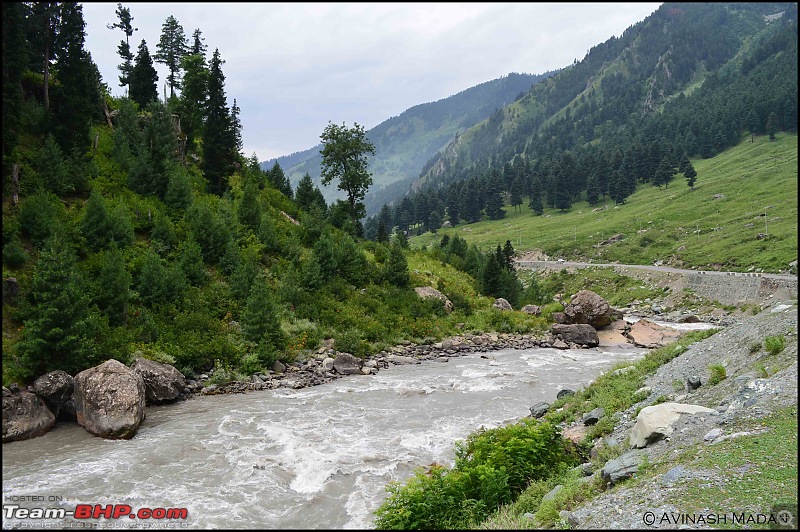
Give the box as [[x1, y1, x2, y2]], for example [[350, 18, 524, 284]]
[[74, 359, 146, 440]]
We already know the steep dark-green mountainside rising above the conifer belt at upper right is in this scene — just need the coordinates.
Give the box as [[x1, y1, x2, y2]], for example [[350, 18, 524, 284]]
[[414, 3, 797, 189]]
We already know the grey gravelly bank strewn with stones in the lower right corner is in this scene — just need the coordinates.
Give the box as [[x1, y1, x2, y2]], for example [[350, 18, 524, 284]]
[[561, 300, 798, 529]]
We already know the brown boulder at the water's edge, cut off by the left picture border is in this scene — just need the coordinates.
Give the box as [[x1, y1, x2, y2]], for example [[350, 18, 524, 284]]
[[3, 386, 56, 443]]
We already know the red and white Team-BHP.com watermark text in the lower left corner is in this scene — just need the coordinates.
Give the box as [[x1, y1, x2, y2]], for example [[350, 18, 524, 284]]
[[3, 504, 189, 520]]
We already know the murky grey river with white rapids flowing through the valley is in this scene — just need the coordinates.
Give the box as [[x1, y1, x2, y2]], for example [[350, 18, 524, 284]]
[[3, 347, 646, 529]]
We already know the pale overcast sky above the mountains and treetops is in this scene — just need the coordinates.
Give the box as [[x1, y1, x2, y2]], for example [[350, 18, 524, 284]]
[[83, 2, 660, 161]]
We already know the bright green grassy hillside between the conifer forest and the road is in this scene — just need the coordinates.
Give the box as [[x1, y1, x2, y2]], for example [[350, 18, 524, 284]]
[[410, 134, 798, 272]]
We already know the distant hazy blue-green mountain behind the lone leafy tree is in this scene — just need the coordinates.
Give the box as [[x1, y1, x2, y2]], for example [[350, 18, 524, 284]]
[[261, 72, 552, 215]]
